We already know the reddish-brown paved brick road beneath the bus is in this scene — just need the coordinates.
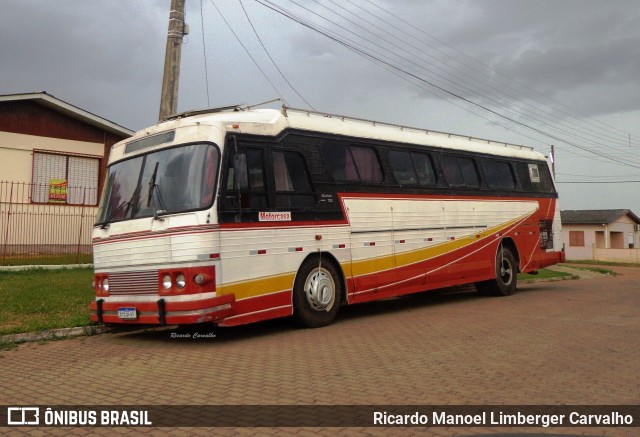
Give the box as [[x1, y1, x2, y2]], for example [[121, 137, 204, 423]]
[[0, 267, 640, 435]]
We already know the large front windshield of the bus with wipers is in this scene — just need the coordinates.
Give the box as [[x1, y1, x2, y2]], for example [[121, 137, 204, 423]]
[[96, 144, 219, 226]]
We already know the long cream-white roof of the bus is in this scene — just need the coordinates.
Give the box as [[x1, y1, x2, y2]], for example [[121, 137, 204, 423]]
[[126, 105, 545, 160]]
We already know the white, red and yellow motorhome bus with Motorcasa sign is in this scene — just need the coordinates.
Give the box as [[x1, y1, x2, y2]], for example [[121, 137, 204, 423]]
[[91, 107, 564, 327]]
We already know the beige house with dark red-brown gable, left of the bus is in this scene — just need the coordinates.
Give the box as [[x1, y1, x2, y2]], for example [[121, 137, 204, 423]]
[[0, 92, 133, 260]]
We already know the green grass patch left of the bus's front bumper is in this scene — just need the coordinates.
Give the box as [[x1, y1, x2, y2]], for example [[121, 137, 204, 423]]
[[0, 267, 95, 335]]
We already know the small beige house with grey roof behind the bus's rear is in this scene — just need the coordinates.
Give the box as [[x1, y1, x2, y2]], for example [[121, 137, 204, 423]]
[[560, 209, 640, 262]]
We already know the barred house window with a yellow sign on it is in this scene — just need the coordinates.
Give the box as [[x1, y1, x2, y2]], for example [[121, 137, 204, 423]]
[[31, 152, 100, 205]]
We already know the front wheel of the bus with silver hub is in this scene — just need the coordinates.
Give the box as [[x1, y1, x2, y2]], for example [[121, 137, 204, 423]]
[[293, 257, 342, 328]]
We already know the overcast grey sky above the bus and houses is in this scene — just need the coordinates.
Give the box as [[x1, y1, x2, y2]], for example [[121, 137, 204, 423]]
[[0, 0, 640, 214]]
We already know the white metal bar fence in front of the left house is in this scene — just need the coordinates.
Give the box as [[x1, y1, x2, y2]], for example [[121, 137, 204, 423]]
[[0, 181, 97, 265]]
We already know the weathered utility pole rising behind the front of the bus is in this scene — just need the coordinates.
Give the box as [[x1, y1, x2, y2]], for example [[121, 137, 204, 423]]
[[159, 0, 188, 121]]
